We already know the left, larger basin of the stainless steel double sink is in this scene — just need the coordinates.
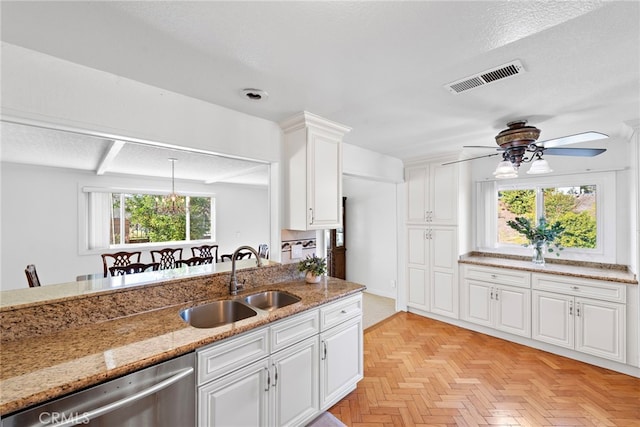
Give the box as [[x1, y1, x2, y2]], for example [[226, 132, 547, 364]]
[[180, 300, 258, 328]]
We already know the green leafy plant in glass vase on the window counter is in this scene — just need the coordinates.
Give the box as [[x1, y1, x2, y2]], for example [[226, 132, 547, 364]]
[[507, 216, 565, 265]]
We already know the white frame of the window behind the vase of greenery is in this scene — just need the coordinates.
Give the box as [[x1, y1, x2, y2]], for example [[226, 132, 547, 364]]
[[476, 172, 617, 263]]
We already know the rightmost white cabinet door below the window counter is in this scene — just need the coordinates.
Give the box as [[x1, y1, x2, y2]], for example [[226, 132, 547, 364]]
[[574, 298, 626, 363]]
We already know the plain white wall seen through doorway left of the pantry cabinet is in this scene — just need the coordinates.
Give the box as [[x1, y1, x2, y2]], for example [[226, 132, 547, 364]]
[[343, 177, 398, 299]]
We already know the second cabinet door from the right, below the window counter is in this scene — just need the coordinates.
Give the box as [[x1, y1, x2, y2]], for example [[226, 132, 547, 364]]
[[532, 291, 574, 349]]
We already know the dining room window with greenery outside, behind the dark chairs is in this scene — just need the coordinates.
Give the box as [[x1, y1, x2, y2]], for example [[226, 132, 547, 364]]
[[84, 189, 215, 250]]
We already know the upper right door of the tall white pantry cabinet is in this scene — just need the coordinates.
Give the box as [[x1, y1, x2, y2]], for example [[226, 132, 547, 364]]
[[427, 163, 458, 225]]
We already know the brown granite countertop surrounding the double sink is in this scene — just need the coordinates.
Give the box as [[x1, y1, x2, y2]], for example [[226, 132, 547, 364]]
[[0, 278, 365, 415]]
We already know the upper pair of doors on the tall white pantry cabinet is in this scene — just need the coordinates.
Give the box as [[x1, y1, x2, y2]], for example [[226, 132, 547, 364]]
[[405, 163, 458, 225]]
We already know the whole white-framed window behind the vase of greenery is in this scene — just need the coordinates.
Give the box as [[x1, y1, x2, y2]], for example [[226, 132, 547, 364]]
[[476, 173, 616, 262]]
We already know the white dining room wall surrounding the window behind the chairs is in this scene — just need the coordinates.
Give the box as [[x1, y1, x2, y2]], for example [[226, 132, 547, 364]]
[[0, 163, 270, 290]]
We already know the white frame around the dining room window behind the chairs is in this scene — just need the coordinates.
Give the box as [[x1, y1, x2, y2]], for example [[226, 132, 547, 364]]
[[78, 186, 217, 255]]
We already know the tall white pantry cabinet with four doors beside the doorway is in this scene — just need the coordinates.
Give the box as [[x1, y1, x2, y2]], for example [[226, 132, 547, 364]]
[[405, 162, 459, 318]]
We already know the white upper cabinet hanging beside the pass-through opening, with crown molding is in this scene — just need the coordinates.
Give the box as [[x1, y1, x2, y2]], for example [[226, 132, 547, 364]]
[[280, 111, 351, 230]]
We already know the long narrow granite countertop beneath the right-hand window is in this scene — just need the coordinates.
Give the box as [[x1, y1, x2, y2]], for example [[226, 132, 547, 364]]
[[458, 252, 638, 285]]
